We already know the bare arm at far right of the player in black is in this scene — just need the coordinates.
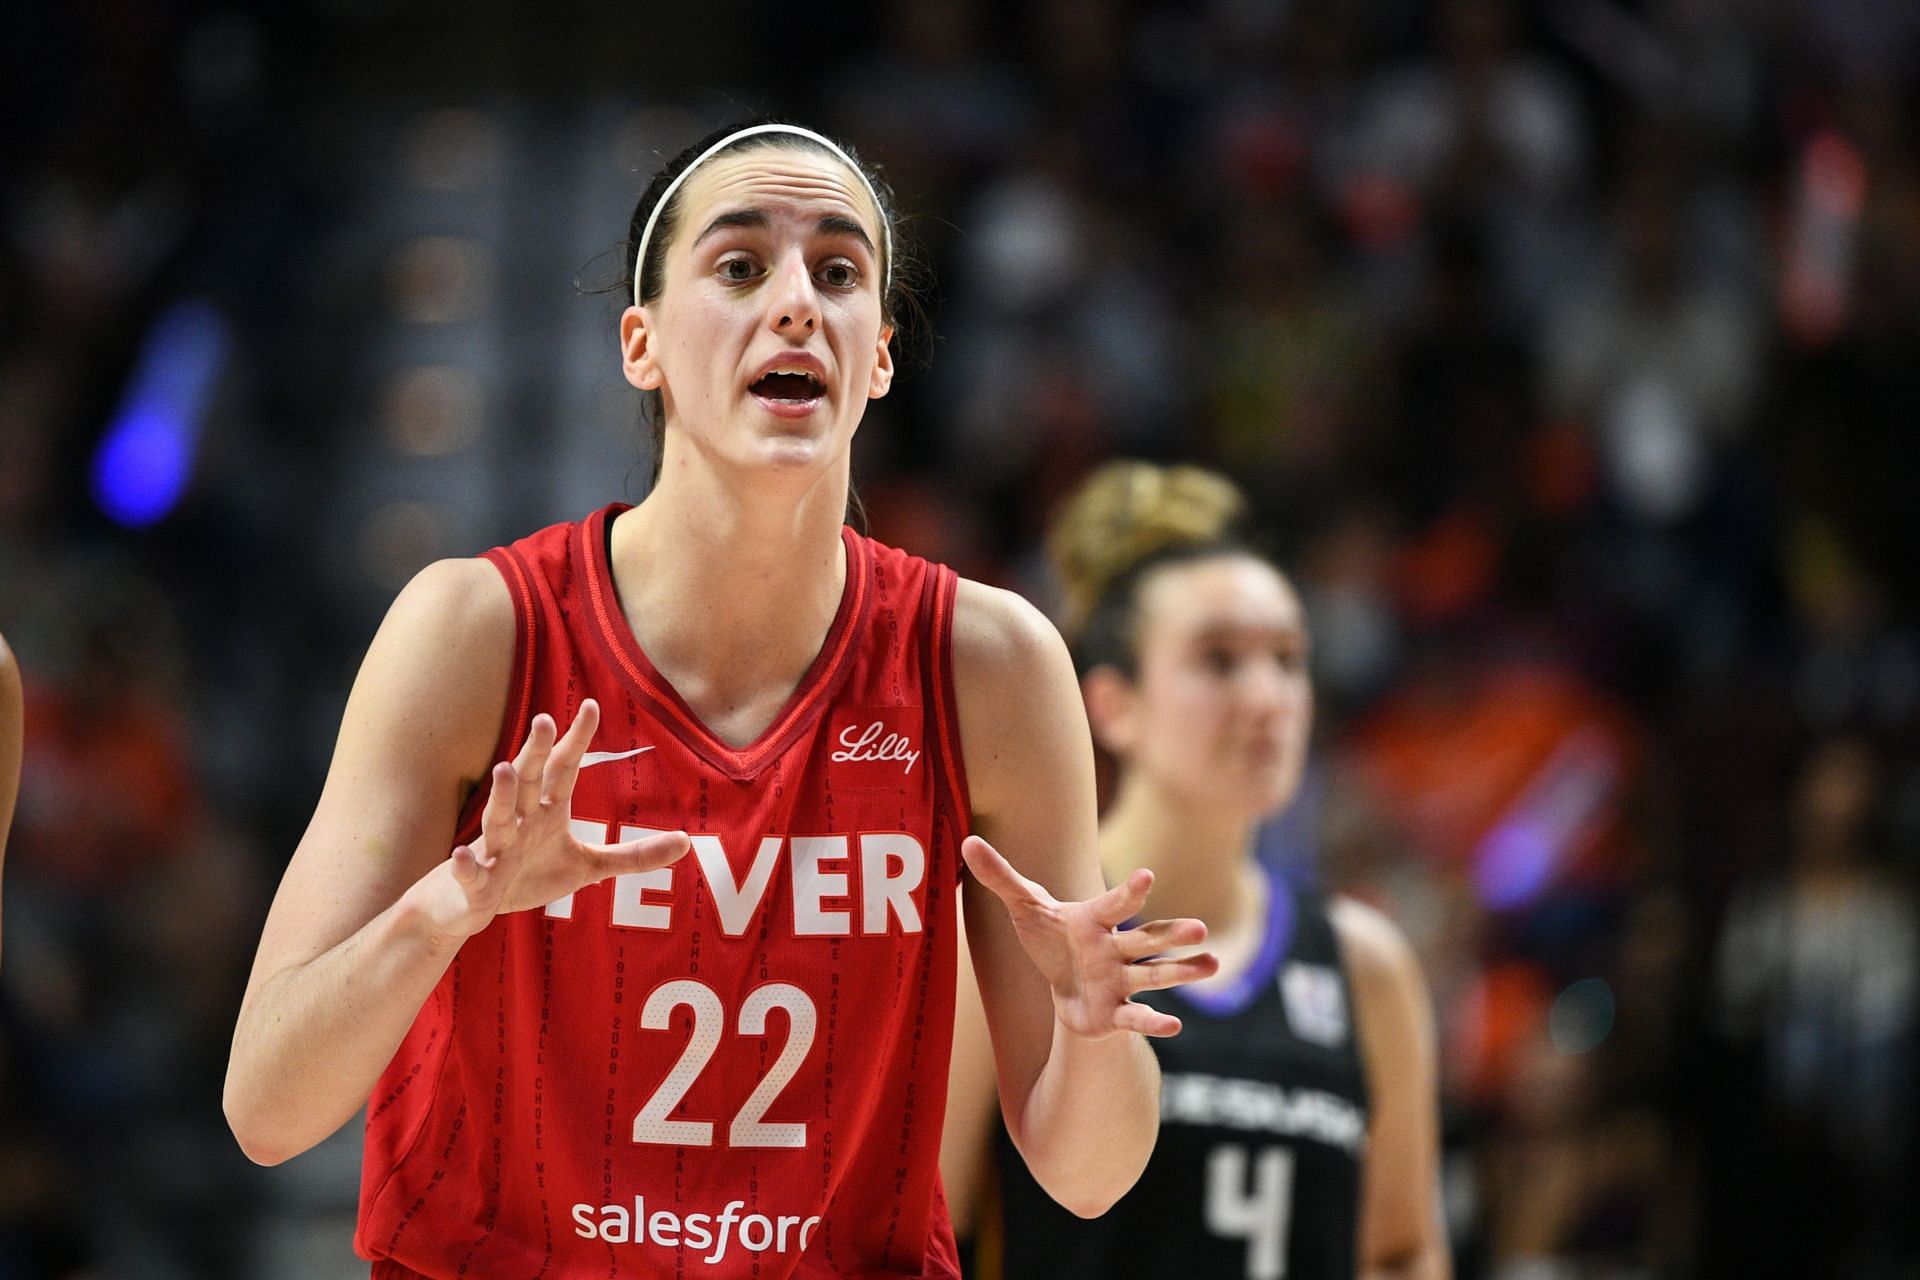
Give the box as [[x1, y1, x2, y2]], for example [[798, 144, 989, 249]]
[[1332, 898, 1448, 1276]]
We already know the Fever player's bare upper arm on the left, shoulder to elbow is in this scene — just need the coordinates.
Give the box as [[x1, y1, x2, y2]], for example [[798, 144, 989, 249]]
[[236, 560, 515, 998]]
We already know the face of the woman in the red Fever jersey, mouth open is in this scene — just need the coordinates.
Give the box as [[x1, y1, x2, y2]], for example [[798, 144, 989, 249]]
[[620, 148, 893, 483]]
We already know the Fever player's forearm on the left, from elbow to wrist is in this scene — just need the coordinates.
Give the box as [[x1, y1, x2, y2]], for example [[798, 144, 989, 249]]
[[225, 898, 459, 1165]]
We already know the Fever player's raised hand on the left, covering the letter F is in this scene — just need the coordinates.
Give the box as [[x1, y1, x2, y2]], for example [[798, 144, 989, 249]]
[[407, 699, 689, 938]]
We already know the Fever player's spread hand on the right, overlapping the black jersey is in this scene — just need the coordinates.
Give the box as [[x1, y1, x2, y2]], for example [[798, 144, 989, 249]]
[[960, 835, 1219, 1040]]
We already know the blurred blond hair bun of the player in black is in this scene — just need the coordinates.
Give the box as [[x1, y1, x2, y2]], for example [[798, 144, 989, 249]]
[[1046, 462, 1246, 635]]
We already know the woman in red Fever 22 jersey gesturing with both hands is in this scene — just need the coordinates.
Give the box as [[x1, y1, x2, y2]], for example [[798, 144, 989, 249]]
[[227, 125, 1213, 1280]]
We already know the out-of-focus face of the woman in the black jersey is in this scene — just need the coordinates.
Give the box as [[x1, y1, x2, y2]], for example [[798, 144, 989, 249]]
[[1100, 555, 1313, 818]]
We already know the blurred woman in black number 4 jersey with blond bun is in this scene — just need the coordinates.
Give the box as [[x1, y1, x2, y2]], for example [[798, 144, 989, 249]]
[[941, 462, 1450, 1280]]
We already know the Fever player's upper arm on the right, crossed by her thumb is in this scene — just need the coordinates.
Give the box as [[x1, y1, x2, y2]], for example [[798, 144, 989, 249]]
[[952, 580, 1104, 1113]]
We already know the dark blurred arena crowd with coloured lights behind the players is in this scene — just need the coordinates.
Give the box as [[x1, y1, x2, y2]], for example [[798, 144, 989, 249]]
[[0, 0, 1920, 1280]]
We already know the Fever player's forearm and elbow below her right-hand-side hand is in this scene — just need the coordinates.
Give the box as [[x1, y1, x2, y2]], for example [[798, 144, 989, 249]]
[[1008, 1019, 1160, 1217]]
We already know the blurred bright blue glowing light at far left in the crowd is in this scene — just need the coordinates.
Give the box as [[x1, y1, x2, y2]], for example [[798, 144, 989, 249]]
[[92, 299, 230, 528]]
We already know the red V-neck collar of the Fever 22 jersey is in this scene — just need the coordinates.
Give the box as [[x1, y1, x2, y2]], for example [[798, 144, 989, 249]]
[[574, 503, 870, 781]]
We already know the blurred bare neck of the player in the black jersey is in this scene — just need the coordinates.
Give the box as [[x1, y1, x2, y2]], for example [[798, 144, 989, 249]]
[[1100, 770, 1263, 935]]
